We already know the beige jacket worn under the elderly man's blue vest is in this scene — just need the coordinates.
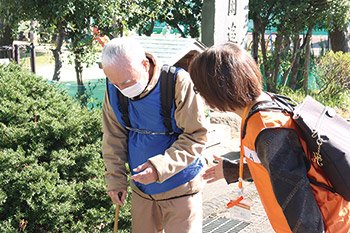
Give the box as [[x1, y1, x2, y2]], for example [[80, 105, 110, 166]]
[[102, 54, 207, 200]]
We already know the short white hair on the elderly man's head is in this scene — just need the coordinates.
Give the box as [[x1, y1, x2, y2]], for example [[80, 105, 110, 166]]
[[102, 37, 146, 69]]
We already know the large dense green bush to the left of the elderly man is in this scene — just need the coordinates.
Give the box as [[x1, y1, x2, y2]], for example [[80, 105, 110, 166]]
[[0, 64, 131, 232]]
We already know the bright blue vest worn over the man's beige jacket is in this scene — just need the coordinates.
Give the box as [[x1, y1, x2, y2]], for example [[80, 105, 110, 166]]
[[107, 70, 203, 195]]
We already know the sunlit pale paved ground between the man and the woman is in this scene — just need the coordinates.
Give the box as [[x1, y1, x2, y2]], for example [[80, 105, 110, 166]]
[[203, 138, 274, 233]]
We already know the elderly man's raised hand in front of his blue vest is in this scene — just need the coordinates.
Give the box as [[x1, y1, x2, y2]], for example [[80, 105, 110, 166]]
[[130, 162, 158, 184]]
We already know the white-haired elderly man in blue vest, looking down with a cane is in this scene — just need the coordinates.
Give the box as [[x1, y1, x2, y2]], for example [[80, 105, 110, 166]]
[[102, 38, 207, 233]]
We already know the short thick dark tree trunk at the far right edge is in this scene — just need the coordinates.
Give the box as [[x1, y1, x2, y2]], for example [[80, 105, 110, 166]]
[[329, 24, 350, 53]]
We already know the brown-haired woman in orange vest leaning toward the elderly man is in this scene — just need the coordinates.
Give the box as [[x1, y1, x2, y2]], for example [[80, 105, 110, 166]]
[[190, 43, 350, 233]]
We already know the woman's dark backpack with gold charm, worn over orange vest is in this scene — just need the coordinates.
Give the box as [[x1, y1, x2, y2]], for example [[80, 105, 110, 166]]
[[243, 93, 350, 201]]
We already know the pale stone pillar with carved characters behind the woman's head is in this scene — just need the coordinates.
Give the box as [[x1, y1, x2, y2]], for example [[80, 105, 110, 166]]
[[202, 0, 249, 48]]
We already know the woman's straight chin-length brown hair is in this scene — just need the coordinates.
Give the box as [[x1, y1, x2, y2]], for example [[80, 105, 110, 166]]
[[189, 43, 262, 111]]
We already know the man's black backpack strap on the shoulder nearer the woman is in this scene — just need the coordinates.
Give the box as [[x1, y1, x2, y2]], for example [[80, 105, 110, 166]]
[[160, 65, 176, 132]]
